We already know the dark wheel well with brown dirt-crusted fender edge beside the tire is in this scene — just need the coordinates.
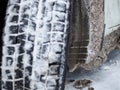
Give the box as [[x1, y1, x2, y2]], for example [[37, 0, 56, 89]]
[[68, 0, 120, 72]]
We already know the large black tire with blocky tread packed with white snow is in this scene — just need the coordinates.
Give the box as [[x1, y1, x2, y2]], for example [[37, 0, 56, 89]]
[[1, 0, 70, 90]]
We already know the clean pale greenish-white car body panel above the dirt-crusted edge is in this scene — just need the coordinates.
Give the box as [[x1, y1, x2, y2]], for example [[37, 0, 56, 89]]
[[104, 0, 120, 35]]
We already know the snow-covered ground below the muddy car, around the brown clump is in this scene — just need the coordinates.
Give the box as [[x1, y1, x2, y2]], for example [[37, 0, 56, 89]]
[[65, 50, 120, 90]]
